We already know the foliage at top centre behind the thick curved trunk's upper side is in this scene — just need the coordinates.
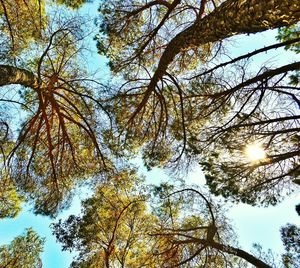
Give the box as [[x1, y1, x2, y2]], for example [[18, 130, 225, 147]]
[[96, 0, 211, 73]]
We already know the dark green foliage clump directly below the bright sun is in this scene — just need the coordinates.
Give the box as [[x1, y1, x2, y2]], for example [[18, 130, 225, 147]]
[[200, 143, 293, 205]]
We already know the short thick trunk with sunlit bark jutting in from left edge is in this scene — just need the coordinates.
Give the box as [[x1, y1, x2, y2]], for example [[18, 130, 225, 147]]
[[0, 65, 38, 88]]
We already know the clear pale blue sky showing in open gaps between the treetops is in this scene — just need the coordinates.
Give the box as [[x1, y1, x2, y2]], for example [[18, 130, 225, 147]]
[[0, 1, 300, 268]]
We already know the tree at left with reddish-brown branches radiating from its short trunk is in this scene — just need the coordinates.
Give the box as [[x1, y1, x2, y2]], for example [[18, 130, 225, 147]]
[[0, 4, 111, 216]]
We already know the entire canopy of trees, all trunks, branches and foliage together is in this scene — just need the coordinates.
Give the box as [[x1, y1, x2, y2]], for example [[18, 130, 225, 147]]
[[0, 0, 300, 268]]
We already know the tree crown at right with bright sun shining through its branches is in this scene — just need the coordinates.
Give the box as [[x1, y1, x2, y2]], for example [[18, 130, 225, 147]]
[[196, 26, 299, 205]]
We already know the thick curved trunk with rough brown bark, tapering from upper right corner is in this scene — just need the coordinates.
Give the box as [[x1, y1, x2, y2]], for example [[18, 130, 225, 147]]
[[149, 0, 300, 85]]
